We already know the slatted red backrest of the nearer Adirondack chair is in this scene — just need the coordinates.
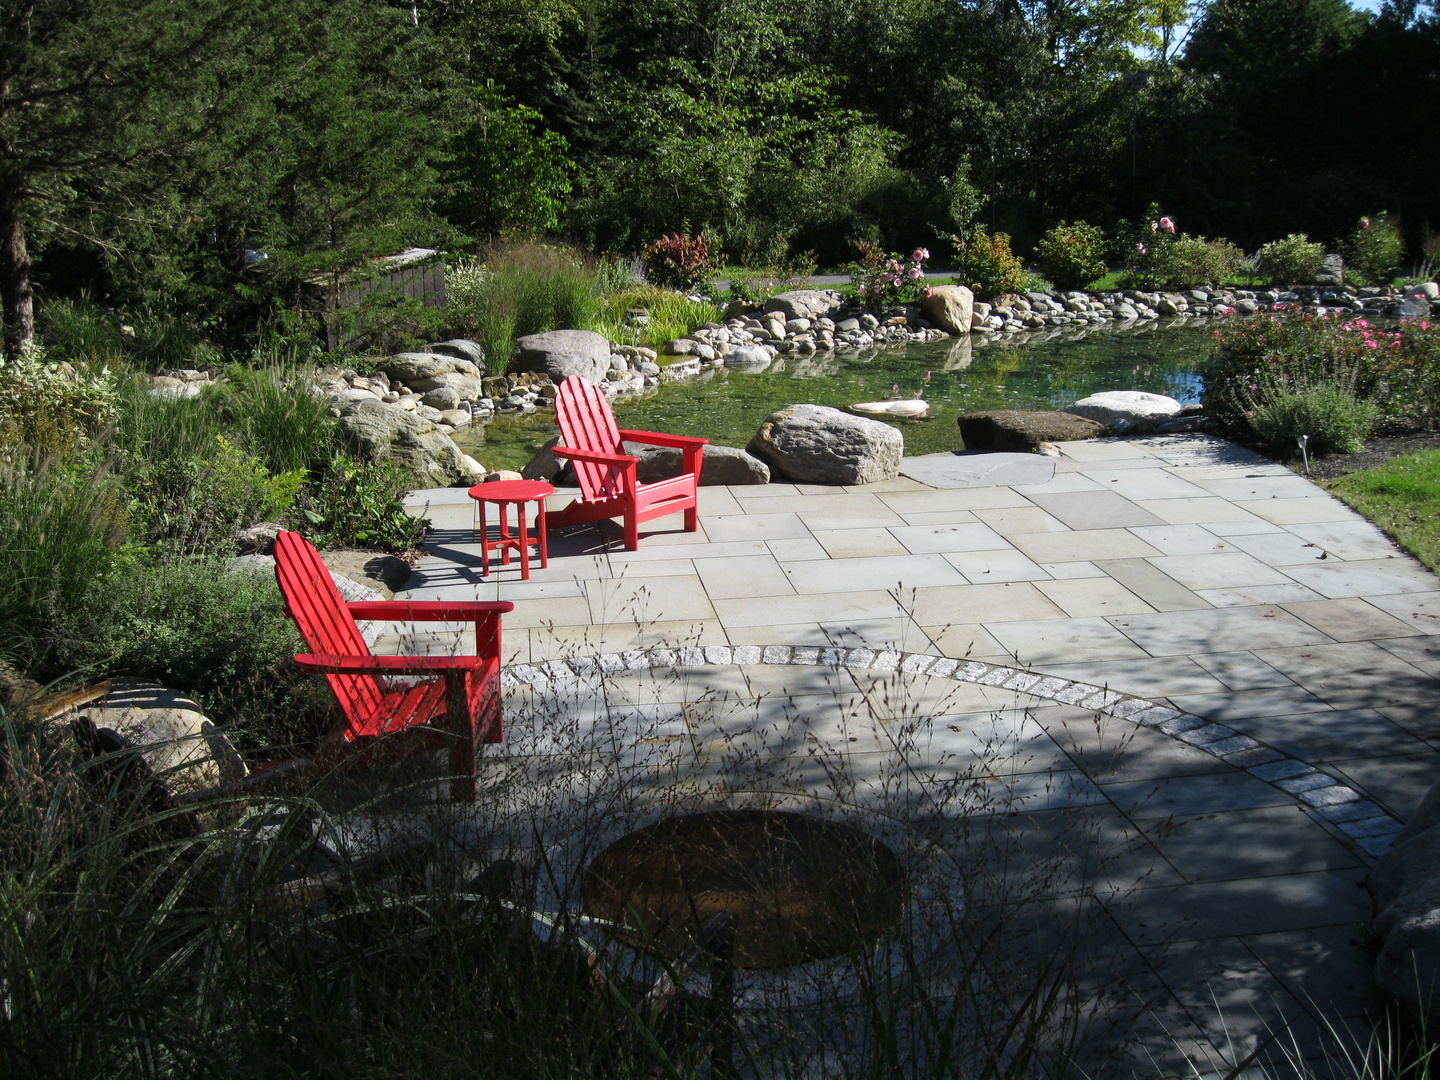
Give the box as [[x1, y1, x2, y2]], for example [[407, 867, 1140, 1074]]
[[275, 533, 384, 723]]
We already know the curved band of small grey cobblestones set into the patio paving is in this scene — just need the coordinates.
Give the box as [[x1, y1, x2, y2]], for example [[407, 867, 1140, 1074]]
[[501, 645, 1401, 860]]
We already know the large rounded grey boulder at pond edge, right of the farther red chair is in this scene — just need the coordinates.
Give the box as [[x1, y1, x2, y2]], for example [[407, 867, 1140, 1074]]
[[746, 405, 904, 484]]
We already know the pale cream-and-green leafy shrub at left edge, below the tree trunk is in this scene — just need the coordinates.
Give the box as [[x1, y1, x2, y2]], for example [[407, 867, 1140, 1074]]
[[0, 346, 118, 454]]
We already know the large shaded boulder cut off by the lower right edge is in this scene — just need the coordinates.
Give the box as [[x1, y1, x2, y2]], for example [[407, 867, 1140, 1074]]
[[1369, 783, 1440, 1028]]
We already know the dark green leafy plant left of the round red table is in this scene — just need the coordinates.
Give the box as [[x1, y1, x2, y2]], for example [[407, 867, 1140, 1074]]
[[289, 458, 429, 552]]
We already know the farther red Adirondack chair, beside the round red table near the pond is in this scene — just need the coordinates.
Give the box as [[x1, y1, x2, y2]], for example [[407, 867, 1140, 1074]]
[[550, 376, 710, 552]]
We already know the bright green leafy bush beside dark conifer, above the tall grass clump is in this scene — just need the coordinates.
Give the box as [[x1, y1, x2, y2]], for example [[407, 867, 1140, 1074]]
[[445, 81, 572, 236]]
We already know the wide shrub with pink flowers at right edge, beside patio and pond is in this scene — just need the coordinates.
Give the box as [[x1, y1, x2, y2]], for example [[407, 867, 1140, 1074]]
[[1200, 308, 1440, 435]]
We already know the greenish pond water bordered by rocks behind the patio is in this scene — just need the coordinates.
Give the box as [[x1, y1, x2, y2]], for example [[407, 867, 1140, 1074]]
[[456, 320, 1211, 469]]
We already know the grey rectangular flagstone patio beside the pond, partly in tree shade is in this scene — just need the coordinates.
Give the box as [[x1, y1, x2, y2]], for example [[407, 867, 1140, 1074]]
[[396, 436, 1440, 1076]]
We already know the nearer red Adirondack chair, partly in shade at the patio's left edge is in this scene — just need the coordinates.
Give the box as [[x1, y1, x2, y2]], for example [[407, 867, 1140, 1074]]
[[275, 533, 514, 801]]
